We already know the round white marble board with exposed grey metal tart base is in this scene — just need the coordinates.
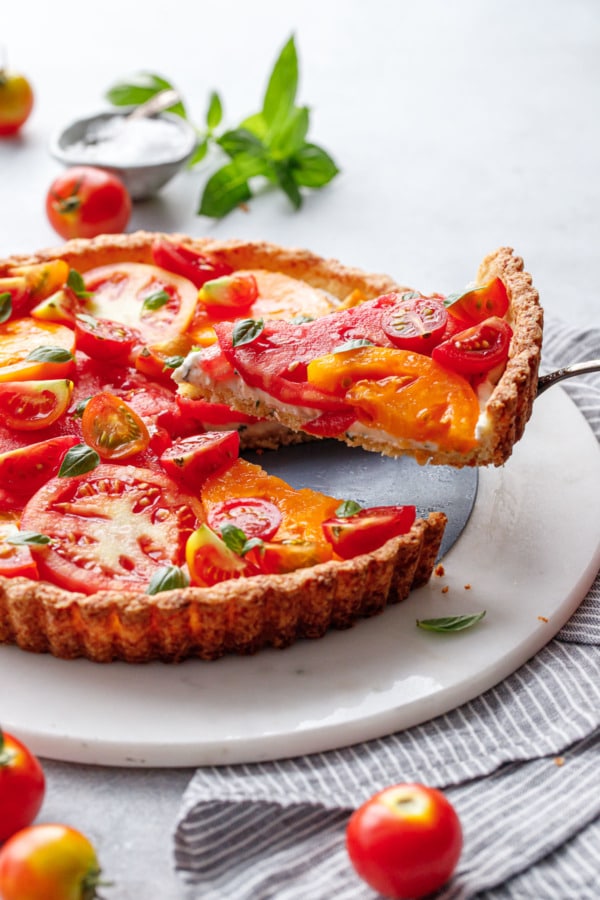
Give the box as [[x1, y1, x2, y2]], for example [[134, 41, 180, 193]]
[[0, 388, 600, 766]]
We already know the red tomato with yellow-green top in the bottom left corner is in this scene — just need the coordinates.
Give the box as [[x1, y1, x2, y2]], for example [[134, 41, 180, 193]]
[[0, 824, 101, 900]]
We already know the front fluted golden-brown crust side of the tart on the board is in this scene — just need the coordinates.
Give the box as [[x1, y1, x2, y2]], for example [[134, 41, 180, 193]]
[[0, 512, 446, 663]]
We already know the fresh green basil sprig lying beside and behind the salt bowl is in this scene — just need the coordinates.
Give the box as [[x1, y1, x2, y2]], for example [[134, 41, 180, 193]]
[[106, 37, 339, 219]]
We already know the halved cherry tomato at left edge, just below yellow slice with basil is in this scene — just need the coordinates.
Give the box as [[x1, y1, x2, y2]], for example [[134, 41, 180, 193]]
[[0, 378, 73, 431]]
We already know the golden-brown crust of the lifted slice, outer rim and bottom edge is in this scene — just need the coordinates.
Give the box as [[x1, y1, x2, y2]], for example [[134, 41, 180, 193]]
[[180, 247, 543, 468]]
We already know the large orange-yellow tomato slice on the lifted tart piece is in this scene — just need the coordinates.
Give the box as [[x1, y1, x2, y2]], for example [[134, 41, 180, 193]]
[[307, 347, 479, 451]]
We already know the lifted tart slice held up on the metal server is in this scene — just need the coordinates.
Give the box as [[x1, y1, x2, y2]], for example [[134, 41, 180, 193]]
[[174, 248, 543, 467]]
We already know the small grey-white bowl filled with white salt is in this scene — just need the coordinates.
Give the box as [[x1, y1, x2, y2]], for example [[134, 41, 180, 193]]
[[50, 110, 198, 200]]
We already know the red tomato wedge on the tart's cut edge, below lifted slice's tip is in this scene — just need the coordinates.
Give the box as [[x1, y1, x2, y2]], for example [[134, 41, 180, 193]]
[[160, 431, 240, 490]]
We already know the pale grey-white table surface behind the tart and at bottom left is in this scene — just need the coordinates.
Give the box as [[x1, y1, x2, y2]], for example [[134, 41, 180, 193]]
[[0, 0, 600, 900]]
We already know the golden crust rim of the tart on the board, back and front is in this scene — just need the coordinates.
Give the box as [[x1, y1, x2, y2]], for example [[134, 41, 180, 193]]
[[0, 232, 446, 663]]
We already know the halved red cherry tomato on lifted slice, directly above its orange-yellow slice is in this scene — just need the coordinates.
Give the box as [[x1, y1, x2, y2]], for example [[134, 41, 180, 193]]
[[431, 316, 512, 375]]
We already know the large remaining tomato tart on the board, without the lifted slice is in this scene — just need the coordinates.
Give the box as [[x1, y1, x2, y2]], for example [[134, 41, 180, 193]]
[[0, 233, 446, 662]]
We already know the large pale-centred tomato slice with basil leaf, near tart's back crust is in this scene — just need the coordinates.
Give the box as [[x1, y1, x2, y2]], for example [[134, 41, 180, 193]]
[[84, 262, 198, 344]]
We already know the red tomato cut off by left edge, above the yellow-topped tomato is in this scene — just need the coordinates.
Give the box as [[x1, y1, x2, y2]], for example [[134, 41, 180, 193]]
[[0, 729, 46, 843]]
